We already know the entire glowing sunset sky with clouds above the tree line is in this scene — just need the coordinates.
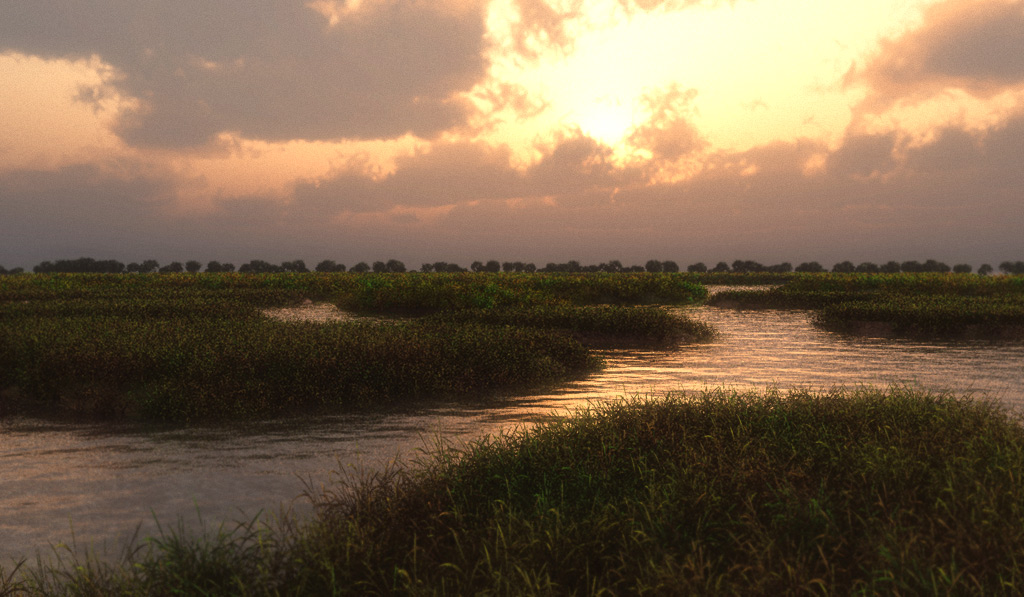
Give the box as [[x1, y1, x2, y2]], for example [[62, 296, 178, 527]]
[[0, 0, 1024, 268]]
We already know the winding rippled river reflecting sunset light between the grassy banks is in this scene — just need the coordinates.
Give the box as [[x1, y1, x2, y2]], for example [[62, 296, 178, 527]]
[[0, 307, 1024, 563]]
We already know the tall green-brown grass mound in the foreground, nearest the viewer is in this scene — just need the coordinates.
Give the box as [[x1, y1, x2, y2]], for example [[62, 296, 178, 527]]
[[8, 388, 1024, 595]]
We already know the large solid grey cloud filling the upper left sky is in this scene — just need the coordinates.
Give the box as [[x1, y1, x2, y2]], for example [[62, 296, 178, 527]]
[[0, 0, 487, 146]]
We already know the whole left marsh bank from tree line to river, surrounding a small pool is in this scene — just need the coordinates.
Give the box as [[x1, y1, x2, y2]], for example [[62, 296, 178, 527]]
[[0, 273, 711, 422]]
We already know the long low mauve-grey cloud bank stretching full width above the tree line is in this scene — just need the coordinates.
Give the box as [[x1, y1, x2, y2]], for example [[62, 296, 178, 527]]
[[0, 115, 1024, 267]]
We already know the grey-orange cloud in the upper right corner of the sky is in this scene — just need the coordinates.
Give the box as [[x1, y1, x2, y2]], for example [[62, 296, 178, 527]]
[[846, 0, 1024, 113]]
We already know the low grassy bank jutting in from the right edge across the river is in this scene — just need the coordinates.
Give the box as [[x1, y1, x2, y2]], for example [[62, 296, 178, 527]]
[[710, 273, 1024, 340]]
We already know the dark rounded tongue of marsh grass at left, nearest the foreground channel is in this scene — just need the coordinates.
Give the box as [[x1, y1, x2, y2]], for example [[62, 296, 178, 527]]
[[0, 316, 599, 422]]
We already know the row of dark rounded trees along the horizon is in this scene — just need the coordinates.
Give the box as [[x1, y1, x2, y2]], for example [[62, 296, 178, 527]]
[[0, 257, 1024, 275]]
